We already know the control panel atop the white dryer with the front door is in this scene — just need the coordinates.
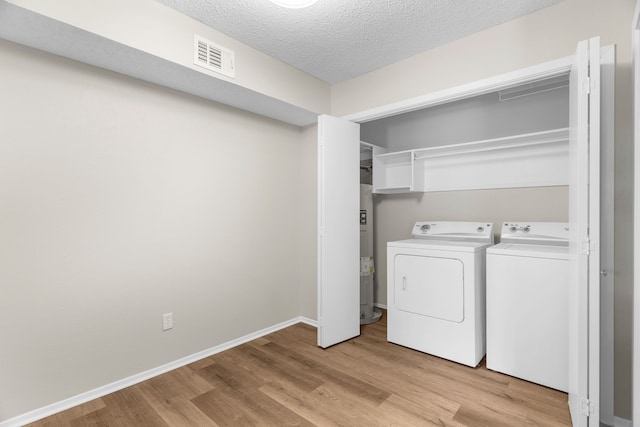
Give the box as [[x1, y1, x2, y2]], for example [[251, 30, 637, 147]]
[[411, 221, 493, 243]]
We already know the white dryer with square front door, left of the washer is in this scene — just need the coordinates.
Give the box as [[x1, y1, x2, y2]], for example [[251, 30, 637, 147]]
[[387, 222, 493, 366]]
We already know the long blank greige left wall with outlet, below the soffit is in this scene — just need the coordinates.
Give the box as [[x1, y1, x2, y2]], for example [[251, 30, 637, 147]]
[[0, 41, 308, 421]]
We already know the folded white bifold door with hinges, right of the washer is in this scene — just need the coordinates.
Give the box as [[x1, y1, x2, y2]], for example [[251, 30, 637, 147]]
[[568, 38, 601, 427]]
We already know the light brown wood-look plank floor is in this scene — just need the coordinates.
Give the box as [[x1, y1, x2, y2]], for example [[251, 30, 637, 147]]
[[31, 313, 571, 427]]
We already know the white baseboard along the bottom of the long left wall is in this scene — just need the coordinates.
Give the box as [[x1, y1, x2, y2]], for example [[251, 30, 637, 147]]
[[0, 317, 310, 427]]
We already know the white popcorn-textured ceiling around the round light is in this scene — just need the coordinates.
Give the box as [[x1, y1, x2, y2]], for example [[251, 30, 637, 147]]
[[158, 0, 562, 83]]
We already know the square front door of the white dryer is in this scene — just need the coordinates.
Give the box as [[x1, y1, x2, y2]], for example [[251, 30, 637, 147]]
[[394, 254, 464, 323]]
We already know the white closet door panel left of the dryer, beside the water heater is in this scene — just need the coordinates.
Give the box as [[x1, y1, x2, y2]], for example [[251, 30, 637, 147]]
[[318, 115, 360, 348]]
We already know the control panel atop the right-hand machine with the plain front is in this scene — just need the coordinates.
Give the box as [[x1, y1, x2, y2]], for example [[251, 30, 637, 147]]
[[500, 222, 569, 246]]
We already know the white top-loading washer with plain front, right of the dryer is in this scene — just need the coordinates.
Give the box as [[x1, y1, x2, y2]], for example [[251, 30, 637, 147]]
[[487, 222, 569, 392]]
